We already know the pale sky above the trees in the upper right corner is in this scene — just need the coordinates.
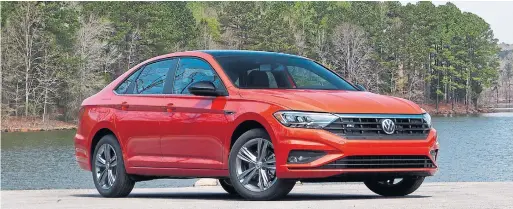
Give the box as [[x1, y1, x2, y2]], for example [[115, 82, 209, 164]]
[[401, 1, 513, 44]]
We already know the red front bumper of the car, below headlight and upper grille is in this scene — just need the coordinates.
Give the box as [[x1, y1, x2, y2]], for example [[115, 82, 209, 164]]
[[275, 126, 439, 179]]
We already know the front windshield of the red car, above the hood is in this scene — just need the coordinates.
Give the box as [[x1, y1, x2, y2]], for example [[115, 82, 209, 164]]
[[216, 55, 356, 91]]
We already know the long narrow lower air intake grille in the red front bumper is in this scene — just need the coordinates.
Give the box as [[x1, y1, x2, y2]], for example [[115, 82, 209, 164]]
[[321, 155, 435, 169]]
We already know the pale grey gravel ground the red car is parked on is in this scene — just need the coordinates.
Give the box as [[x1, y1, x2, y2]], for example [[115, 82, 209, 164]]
[[1, 182, 513, 209]]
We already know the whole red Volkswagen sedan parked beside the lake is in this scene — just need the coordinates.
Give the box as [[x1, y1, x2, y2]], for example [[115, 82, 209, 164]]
[[75, 51, 438, 200]]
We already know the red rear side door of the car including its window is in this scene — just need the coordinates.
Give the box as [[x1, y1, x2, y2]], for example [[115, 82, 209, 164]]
[[116, 59, 178, 167]]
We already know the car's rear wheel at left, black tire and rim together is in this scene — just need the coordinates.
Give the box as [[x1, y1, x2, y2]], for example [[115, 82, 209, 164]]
[[91, 135, 135, 197]]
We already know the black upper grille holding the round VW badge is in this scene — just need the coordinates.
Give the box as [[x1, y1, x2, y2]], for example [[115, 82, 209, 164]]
[[324, 114, 430, 139]]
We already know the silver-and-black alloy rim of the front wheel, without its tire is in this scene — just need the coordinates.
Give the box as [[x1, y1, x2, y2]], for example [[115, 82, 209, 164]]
[[236, 138, 277, 192]]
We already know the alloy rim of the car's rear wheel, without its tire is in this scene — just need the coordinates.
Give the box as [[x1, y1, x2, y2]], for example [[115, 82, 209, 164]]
[[95, 144, 118, 189]]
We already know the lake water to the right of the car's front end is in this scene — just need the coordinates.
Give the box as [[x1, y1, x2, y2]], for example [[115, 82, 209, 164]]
[[428, 113, 513, 181]]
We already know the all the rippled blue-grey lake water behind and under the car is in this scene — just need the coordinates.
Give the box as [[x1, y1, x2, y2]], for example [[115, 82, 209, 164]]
[[1, 113, 513, 190]]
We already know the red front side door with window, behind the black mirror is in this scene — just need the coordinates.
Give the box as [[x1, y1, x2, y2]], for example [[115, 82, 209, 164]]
[[161, 57, 229, 169]]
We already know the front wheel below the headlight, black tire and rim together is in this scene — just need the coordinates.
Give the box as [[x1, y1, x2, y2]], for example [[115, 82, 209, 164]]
[[228, 129, 296, 200]]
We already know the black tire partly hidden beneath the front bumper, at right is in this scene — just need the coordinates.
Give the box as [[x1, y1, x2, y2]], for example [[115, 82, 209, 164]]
[[364, 177, 424, 197]]
